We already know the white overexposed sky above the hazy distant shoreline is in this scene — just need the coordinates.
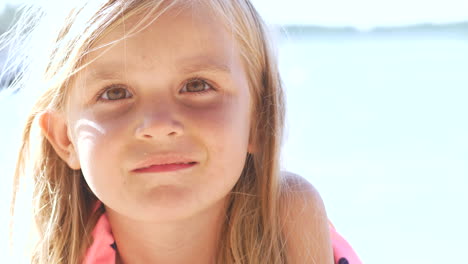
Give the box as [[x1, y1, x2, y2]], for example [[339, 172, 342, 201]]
[[0, 0, 468, 30]]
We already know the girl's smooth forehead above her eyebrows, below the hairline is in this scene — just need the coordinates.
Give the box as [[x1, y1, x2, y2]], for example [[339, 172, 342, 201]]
[[81, 4, 240, 76]]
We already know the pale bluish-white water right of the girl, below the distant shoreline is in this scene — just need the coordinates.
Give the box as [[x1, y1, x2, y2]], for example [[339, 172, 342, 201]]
[[280, 28, 468, 264]]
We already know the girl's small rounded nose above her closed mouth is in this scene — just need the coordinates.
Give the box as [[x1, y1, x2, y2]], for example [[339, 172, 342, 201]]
[[135, 109, 184, 140]]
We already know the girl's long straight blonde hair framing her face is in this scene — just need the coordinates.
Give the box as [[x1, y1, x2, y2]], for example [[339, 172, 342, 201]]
[[5, 0, 287, 264]]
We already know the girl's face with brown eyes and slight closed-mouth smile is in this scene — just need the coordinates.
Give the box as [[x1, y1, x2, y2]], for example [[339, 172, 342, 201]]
[[67, 5, 251, 221]]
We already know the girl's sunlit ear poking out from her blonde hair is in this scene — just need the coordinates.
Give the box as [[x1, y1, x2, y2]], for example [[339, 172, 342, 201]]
[[39, 111, 81, 170]]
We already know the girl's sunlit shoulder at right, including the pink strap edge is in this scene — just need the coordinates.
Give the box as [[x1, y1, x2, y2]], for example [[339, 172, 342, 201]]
[[279, 172, 361, 264]]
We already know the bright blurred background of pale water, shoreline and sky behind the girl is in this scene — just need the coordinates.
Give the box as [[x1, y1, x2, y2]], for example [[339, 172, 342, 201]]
[[0, 0, 468, 264]]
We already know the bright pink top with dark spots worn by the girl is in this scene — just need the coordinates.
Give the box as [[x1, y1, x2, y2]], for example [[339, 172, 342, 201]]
[[83, 213, 362, 264]]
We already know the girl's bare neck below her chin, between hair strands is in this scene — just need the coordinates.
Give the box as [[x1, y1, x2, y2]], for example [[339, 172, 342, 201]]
[[107, 199, 226, 264]]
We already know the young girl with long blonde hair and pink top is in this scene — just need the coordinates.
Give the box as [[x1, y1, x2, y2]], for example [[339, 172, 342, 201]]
[[4, 0, 360, 264]]
